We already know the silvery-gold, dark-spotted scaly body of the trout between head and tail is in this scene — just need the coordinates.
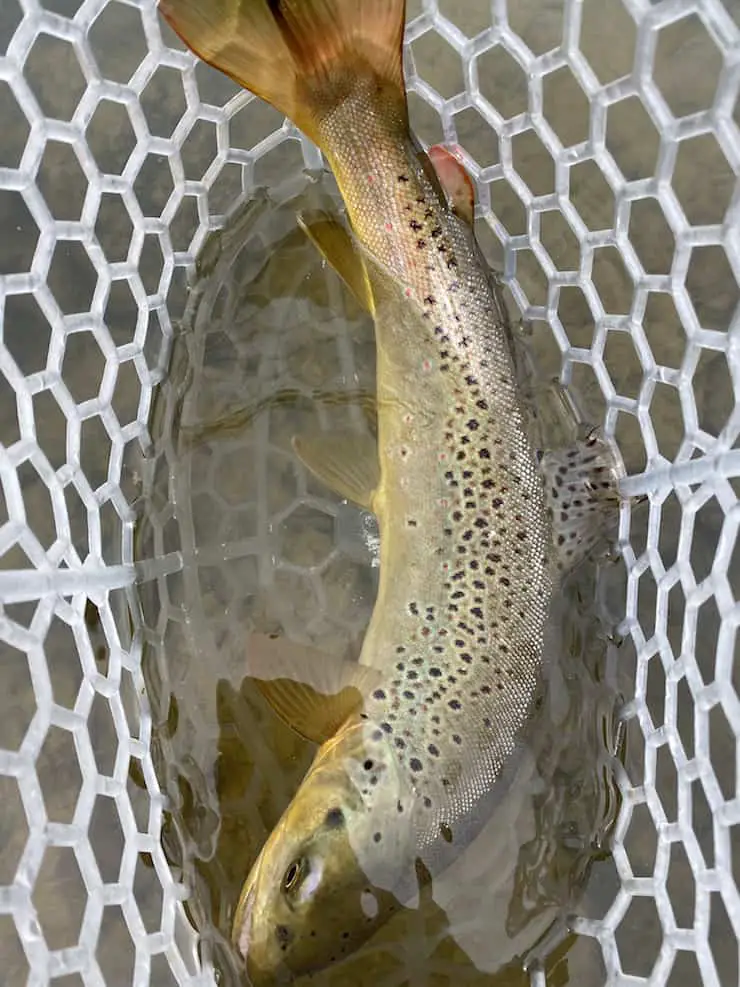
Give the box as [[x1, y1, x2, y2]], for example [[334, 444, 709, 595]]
[[322, 91, 552, 842]]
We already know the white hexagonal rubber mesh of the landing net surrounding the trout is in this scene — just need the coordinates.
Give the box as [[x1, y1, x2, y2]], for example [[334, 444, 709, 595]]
[[0, 0, 740, 987]]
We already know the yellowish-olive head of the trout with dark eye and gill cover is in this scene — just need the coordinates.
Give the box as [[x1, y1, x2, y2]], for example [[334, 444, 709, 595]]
[[233, 721, 416, 985]]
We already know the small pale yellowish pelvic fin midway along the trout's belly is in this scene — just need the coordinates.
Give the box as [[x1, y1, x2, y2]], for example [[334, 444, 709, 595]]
[[293, 429, 380, 510]]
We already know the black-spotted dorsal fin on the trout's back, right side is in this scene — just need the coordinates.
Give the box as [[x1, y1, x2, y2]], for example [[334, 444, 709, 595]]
[[540, 430, 624, 573]]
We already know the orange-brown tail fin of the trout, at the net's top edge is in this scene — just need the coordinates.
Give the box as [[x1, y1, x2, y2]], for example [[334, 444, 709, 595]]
[[159, 0, 405, 140]]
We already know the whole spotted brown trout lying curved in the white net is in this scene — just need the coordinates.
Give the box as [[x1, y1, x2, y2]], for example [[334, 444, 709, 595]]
[[159, 0, 621, 984]]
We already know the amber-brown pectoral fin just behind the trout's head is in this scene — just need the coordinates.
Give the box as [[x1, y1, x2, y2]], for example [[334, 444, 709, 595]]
[[247, 634, 380, 744]]
